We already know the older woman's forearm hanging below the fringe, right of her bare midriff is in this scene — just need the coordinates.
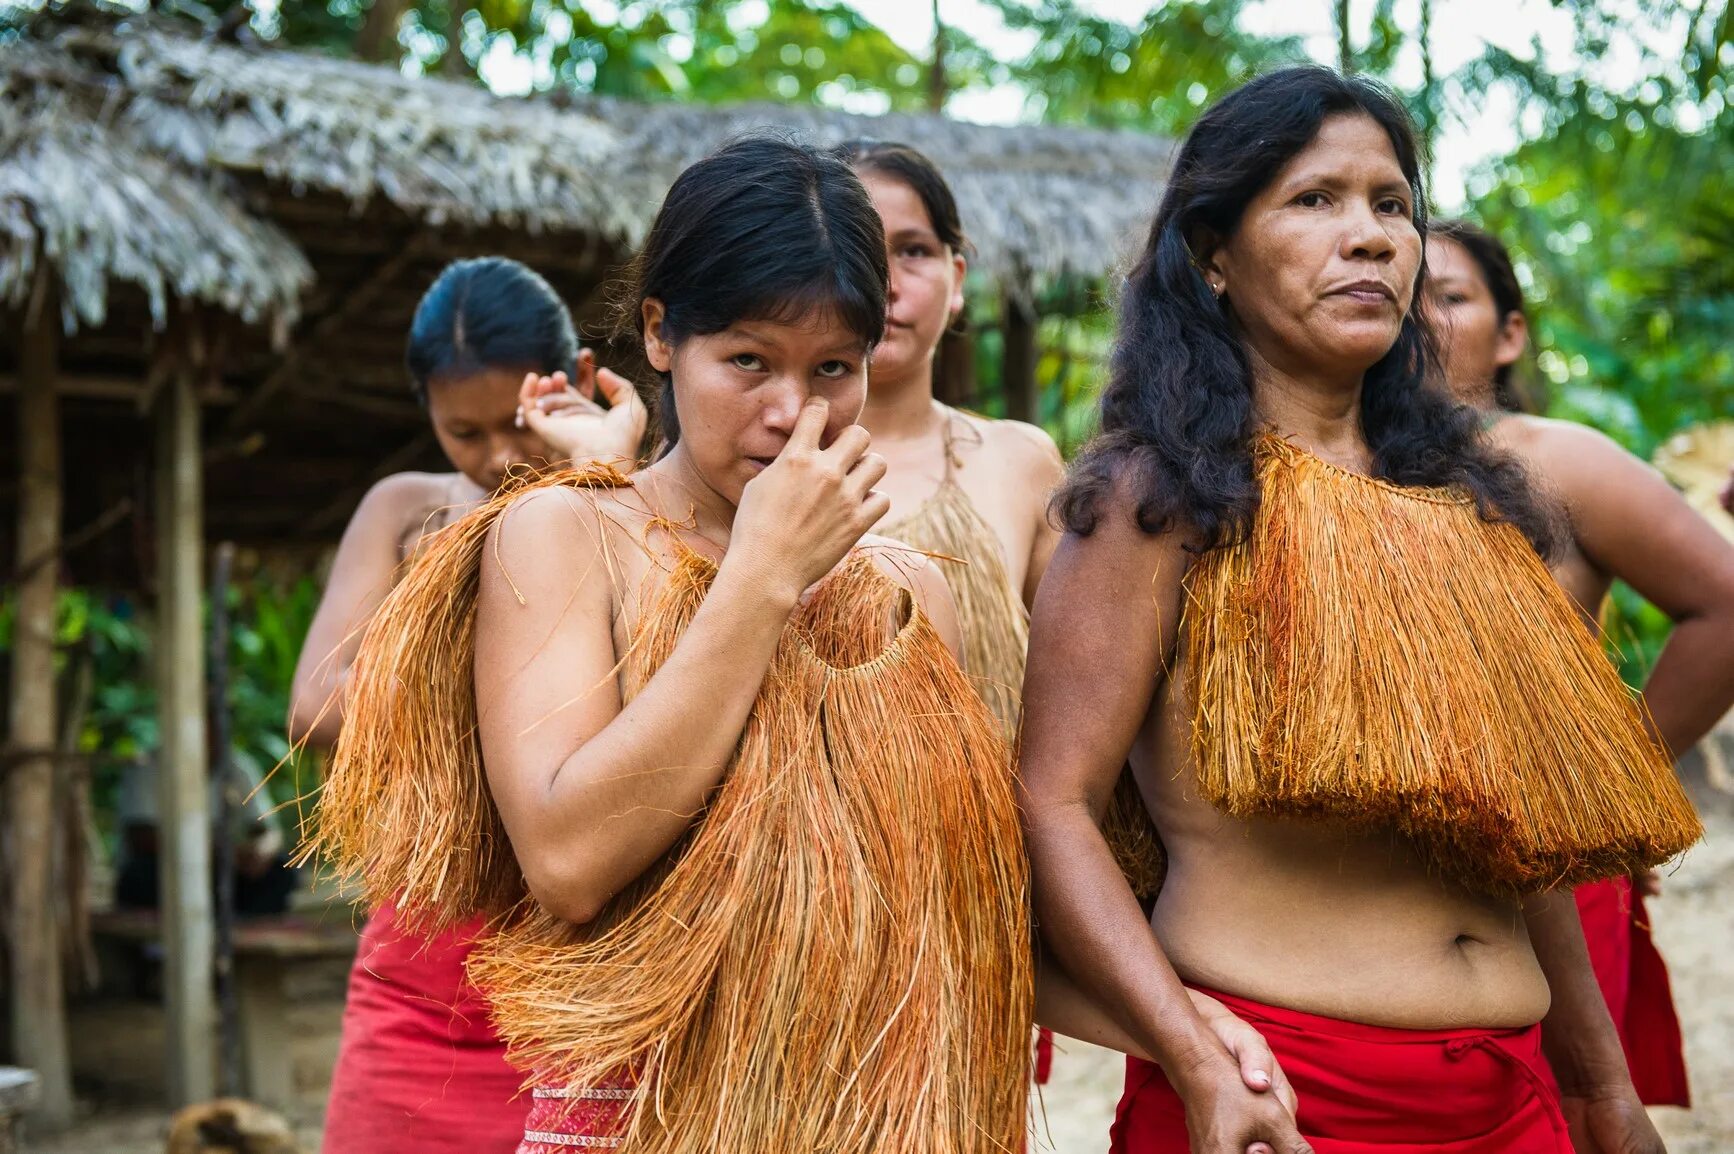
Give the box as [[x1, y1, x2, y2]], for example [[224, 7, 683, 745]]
[[1522, 891, 1663, 1154]]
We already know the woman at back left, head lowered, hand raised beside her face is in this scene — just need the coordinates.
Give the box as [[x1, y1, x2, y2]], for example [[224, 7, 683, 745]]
[[290, 258, 647, 1154]]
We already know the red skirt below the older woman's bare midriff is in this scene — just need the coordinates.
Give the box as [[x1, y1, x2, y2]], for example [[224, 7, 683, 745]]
[[1111, 989, 1571, 1154]]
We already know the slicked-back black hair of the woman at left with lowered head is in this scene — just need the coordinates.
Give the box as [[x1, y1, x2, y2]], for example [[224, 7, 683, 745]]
[[404, 256, 577, 404]]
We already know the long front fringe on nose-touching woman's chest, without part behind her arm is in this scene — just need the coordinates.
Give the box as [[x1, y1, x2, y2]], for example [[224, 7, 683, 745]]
[[470, 553, 1033, 1154]]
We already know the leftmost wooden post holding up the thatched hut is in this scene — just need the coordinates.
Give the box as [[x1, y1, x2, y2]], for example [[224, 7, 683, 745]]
[[0, 269, 73, 1130]]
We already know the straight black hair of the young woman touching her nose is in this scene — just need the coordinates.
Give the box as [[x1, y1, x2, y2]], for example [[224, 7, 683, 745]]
[[616, 133, 891, 445]]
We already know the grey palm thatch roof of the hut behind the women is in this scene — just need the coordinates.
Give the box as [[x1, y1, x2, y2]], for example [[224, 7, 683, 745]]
[[0, 5, 1172, 585]]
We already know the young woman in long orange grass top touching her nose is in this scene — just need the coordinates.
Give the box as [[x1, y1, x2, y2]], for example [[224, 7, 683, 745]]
[[306, 139, 1032, 1154]]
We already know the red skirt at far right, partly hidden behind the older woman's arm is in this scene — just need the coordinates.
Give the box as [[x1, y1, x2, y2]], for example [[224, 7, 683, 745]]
[[1576, 877, 1692, 1105]]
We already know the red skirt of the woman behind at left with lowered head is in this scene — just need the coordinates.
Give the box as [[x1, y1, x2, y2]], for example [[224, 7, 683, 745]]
[[321, 908, 531, 1154]]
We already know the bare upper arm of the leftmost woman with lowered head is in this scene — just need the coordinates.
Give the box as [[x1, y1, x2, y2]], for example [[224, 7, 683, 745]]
[[290, 473, 428, 747]]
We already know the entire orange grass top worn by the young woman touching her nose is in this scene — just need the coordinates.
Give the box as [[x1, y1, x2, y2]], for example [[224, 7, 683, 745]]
[[301, 471, 1033, 1154]]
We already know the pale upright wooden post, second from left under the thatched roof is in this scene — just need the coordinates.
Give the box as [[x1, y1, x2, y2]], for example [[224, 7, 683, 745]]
[[156, 334, 215, 1107]]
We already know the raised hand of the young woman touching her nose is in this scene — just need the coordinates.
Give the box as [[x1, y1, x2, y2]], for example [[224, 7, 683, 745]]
[[723, 397, 891, 605]]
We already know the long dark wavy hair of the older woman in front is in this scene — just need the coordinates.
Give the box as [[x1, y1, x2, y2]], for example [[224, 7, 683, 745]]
[[1054, 66, 1559, 556]]
